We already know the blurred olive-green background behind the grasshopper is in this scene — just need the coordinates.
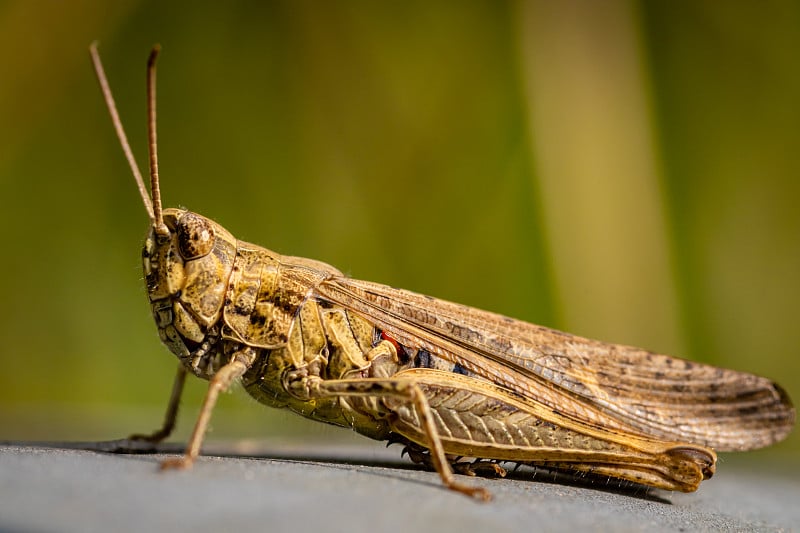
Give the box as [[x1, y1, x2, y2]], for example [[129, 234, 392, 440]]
[[0, 0, 800, 457]]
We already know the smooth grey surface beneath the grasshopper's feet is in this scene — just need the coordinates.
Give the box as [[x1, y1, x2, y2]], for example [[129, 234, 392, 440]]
[[0, 443, 800, 533]]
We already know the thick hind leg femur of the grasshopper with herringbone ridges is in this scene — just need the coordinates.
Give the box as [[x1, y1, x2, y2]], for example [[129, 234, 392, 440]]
[[385, 370, 716, 491]]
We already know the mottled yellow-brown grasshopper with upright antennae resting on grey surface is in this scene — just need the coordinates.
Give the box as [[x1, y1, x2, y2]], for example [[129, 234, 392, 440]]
[[90, 44, 795, 500]]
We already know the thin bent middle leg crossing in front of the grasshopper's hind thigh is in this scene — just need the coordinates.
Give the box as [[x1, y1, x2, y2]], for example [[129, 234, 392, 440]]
[[285, 374, 491, 501]]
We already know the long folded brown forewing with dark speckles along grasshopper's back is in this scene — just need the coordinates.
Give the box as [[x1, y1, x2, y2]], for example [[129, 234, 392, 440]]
[[317, 277, 794, 451]]
